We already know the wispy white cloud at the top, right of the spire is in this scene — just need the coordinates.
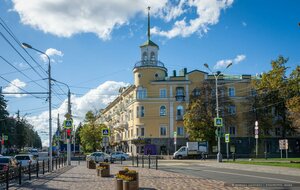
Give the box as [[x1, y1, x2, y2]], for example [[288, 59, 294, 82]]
[[151, 0, 233, 38]]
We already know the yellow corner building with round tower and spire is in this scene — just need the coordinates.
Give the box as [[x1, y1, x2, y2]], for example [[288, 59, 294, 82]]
[[99, 10, 253, 155]]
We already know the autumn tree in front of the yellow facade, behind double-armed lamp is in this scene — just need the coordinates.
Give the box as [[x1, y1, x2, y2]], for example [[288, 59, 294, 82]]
[[184, 82, 235, 150]]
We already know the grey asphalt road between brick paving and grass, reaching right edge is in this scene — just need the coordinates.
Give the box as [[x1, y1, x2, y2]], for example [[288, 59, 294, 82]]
[[159, 160, 300, 189]]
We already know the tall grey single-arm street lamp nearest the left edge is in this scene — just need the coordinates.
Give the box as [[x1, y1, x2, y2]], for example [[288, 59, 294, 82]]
[[22, 43, 52, 171]]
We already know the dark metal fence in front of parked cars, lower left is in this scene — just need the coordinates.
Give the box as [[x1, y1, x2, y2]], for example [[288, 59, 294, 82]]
[[0, 157, 67, 189]]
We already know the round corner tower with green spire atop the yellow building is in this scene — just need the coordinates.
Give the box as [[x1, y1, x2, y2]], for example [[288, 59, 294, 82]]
[[133, 7, 167, 87]]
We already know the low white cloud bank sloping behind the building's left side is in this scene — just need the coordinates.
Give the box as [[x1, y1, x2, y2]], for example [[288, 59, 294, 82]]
[[28, 81, 129, 146]]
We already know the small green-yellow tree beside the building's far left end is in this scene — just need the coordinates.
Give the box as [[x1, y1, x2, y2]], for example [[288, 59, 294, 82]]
[[79, 111, 106, 152]]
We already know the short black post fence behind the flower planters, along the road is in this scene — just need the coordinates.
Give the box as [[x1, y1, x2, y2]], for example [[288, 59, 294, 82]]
[[114, 155, 159, 170]]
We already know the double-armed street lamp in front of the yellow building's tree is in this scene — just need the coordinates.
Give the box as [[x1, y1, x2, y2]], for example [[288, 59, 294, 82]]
[[204, 63, 232, 162]]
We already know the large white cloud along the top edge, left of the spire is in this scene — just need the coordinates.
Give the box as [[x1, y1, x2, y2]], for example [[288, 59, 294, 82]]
[[13, 0, 167, 40]]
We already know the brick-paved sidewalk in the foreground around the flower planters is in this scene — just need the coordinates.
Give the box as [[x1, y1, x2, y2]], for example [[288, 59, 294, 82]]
[[10, 162, 254, 190]]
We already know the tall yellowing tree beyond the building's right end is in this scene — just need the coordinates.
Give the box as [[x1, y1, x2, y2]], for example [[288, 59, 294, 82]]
[[253, 56, 295, 137]]
